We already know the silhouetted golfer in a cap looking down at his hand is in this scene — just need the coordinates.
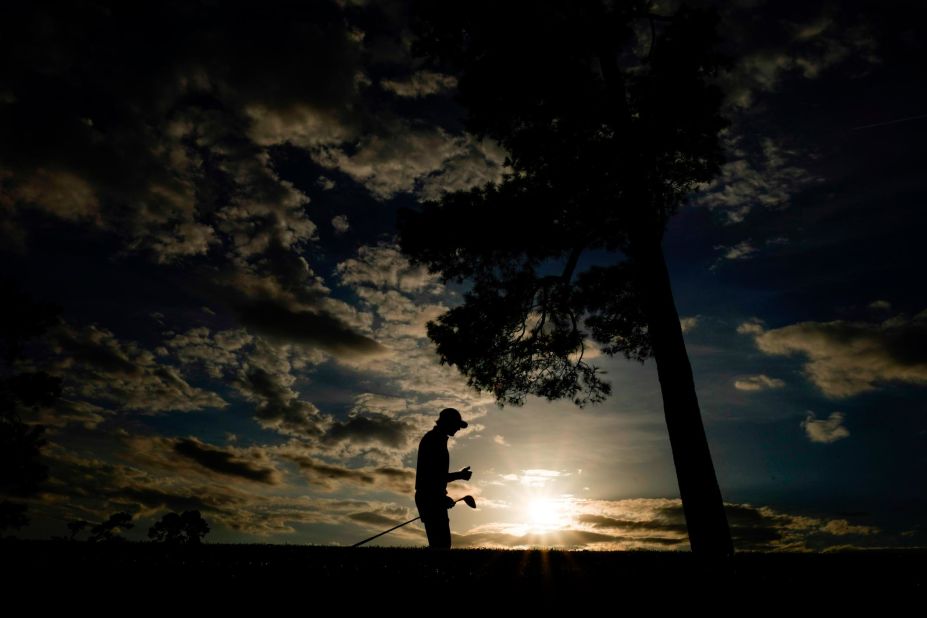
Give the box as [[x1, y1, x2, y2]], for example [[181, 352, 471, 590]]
[[415, 408, 472, 549]]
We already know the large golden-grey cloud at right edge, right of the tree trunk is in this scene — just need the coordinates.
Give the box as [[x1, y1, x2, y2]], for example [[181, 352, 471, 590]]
[[738, 312, 927, 398]]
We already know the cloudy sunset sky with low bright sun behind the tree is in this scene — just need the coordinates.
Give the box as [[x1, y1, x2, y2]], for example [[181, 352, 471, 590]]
[[0, 0, 927, 551]]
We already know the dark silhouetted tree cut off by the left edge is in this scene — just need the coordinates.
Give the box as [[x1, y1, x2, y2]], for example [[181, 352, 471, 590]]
[[0, 280, 61, 532]]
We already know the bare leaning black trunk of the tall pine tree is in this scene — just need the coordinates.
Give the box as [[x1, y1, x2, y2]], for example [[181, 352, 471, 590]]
[[634, 240, 734, 557]]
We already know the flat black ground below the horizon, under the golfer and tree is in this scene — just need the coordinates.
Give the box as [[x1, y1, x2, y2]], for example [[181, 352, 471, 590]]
[[0, 540, 927, 604]]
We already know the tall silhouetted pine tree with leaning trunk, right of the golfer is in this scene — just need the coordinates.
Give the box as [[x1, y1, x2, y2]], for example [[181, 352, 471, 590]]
[[399, 0, 733, 555]]
